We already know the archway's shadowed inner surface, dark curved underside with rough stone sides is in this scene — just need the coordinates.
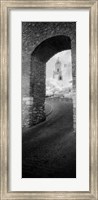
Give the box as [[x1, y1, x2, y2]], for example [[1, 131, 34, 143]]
[[29, 35, 76, 126]]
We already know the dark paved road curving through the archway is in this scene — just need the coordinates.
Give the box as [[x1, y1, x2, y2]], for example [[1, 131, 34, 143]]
[[22, 99, 76, 178]]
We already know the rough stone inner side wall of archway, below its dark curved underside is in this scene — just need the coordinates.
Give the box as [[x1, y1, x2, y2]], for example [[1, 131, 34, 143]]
[[29, 55, 46, 126]]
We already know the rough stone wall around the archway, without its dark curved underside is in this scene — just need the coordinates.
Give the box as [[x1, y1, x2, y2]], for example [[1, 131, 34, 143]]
[[22, 22, 76, 127]]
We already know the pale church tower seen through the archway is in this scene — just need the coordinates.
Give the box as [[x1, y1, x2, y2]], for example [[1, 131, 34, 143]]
[[53, 58, 63, 81]]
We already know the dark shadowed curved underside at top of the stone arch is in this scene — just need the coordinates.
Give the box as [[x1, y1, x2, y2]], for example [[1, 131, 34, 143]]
[[32, 35, 71, 63]]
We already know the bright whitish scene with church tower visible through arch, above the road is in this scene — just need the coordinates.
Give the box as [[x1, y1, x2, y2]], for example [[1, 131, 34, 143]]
[[46, 51, 72, 96]]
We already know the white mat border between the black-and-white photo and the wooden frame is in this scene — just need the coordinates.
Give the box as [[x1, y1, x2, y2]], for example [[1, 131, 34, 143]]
[[9, 9, 89, 191]]
